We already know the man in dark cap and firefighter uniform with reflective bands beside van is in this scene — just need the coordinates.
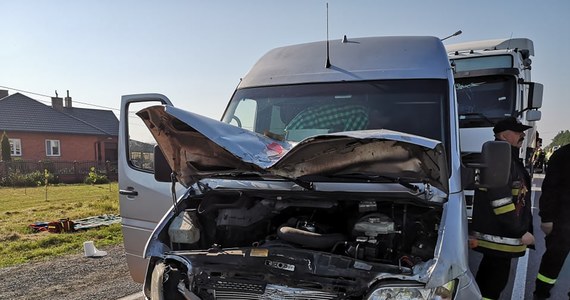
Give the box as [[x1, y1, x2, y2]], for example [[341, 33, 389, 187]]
[[470, 117, 534, 299]]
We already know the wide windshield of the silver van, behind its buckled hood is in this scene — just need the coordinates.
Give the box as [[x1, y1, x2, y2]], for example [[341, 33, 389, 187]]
[[223, 80, 449, 144]]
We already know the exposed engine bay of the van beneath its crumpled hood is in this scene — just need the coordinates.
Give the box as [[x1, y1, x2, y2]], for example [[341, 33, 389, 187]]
[[164, 192, 441, 267]]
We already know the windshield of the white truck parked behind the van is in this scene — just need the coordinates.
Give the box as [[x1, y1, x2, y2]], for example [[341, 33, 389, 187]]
[[455, 75, 516, 128]]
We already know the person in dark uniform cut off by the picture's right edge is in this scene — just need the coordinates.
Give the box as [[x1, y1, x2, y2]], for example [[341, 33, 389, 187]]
[[534, 144, 570, 299]]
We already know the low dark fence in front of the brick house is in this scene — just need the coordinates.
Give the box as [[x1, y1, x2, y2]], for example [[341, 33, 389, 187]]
[[0, 160, 118, 183]]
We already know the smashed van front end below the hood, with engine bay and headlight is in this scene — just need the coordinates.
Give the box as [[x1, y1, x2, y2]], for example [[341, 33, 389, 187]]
[[145, 180, 455, 299]]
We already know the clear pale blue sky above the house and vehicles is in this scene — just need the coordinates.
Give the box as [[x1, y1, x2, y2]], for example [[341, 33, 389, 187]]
[[0, 0, 570, 145]]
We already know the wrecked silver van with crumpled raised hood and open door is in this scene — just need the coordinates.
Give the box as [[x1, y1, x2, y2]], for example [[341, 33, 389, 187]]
[[119, 37, 510, 300]]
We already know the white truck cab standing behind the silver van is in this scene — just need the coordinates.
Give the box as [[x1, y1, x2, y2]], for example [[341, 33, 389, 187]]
[[445, 38, 543, 217]]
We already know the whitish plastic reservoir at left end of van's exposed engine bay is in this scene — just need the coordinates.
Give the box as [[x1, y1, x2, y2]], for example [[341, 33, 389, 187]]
[[168, 210, 200, 244]]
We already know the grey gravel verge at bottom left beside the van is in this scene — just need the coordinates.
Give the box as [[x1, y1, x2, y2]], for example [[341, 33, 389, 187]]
[[0, 245, 142, 300]]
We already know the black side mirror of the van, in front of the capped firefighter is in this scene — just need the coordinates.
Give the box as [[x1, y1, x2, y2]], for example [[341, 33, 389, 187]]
[[467, 141, 511, 188]]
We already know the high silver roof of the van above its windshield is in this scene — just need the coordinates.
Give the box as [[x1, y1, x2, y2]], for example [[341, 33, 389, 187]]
[[238, 36, 450, 88]]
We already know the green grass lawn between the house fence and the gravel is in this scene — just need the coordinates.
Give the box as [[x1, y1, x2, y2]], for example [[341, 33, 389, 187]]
[[0, 182, 123, 268]]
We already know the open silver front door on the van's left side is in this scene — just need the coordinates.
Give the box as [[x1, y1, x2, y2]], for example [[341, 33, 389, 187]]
[[119, 94, 182, 283]]
